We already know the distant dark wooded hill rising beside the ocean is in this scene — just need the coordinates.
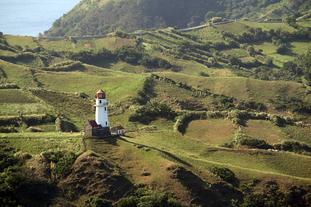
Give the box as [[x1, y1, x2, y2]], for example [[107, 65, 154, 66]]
[[44, 0, 310, 37]]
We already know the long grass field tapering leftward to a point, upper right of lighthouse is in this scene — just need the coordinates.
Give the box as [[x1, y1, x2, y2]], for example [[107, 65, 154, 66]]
[[156, 72, 305, 102]]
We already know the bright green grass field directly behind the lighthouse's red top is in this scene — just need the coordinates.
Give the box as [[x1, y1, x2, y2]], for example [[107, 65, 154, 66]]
[[36, 65, 145, 103]]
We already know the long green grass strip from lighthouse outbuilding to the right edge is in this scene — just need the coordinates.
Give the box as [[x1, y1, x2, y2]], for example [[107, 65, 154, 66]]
[[126, 131, 311, 180]]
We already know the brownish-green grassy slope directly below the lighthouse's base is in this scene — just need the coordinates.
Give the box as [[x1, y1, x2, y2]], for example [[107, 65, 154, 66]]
[[85, 138, 180, 187]]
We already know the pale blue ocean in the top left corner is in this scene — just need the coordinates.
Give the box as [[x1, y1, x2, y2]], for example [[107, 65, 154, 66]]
[[0, 0, 81, 37]]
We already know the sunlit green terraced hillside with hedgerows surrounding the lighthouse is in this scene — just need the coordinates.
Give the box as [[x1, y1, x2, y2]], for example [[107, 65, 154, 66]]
[[0, 19, 311, 207]]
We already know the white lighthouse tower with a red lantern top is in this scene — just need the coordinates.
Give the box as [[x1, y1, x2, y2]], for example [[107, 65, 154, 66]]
[[95, 89, 109, 128]]
